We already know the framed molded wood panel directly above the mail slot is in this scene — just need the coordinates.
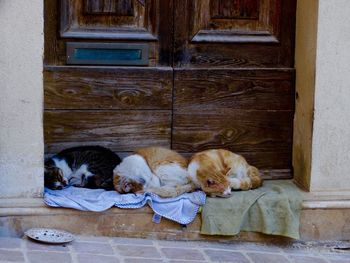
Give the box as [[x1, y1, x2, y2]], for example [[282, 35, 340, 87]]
[[60, 0, 159, 41]]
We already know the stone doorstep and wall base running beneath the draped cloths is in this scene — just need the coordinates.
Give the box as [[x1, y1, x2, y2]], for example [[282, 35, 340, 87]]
[[0, 182, 350, 242]]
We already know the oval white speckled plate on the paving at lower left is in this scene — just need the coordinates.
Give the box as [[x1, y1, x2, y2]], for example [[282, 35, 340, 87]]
[[25, 228, 74, 244]]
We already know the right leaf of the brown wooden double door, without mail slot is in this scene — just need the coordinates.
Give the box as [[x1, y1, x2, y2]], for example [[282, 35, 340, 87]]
[[172, 0, 296, 178]]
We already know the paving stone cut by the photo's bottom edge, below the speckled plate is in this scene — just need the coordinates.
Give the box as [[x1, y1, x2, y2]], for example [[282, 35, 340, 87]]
[[27, 251, 72, 263]]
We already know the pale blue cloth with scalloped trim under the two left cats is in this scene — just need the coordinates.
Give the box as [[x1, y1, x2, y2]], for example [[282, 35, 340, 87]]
[[44, 186, 205, 225]]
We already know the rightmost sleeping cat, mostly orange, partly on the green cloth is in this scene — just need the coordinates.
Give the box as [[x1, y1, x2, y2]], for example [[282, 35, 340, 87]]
[[188, 149, 262, 197]]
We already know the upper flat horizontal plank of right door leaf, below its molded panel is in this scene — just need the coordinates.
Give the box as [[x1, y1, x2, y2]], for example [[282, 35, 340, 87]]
[[174, 69, 295, 111]]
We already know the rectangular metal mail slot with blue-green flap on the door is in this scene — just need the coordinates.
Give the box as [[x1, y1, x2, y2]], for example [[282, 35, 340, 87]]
[[67, 42, 148, 66]]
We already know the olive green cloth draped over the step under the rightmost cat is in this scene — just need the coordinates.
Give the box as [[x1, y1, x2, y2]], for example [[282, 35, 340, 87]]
[[201, 180, 302, 239]]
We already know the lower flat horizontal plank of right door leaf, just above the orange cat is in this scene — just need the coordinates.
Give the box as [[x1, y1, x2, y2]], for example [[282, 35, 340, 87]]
[[172, 108, 293, 153]]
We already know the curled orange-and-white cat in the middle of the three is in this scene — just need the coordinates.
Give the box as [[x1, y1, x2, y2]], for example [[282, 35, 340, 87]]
[[113, 147, 195, 197]]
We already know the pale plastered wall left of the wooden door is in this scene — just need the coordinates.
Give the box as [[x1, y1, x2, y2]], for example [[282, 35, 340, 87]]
[[0, 0, 44, 197]]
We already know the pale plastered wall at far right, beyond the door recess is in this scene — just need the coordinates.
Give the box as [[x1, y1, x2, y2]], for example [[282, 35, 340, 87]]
[[310, 0, 350, 193]]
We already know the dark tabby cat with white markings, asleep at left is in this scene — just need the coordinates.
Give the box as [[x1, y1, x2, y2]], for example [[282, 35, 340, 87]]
[[44, 146, 120, 190]]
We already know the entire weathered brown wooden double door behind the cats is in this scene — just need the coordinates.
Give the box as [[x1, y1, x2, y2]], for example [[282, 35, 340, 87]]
[[44, 0, 296, 178]]
